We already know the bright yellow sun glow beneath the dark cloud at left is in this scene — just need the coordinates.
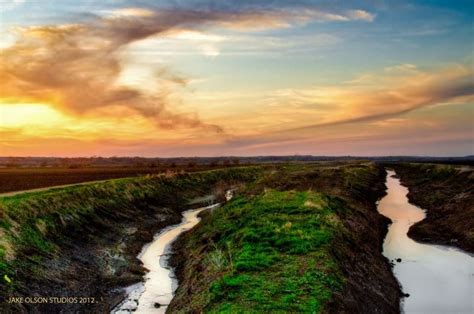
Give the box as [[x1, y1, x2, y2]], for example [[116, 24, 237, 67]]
[[0, 101, 206, 141]]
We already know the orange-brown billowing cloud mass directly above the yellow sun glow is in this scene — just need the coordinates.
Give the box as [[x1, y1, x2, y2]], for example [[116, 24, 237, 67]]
[[0, 21, 218, 132]]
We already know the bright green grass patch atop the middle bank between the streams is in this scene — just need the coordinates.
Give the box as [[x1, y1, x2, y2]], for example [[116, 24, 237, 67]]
[[180, 190, 344, 313]]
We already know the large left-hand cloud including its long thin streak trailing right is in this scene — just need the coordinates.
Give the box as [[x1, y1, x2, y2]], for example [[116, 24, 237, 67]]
[[0, 8, 374, 133]]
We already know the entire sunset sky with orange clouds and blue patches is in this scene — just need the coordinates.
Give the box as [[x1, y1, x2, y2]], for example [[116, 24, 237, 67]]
[[0, 0, 474, 157]]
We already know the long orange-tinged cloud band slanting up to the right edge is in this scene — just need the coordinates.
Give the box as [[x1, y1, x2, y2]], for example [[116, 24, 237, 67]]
[[193, 64, 474, 145]]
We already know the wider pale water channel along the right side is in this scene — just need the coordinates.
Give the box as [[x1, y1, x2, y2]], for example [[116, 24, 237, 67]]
[[378, 171, 474, 313]]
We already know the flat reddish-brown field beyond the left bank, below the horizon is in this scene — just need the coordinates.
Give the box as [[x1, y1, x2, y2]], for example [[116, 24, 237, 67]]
[[0, 165, 224, 193]]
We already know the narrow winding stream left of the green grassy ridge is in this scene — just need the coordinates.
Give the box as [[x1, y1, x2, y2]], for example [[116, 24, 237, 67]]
[[112, 204, 218, 314]]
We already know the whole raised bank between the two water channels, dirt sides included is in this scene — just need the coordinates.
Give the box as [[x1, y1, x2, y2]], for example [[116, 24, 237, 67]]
[[168, 164, 401, 313]]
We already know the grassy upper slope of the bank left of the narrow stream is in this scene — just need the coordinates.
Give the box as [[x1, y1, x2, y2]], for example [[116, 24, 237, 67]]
[[0, 167, 262, 310]]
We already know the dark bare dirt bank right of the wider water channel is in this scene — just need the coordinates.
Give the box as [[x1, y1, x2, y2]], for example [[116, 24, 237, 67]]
[[390, 164, 474, 253]]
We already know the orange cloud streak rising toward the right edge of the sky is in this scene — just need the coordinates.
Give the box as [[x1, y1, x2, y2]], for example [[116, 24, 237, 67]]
[[264, 64, 474, 132]]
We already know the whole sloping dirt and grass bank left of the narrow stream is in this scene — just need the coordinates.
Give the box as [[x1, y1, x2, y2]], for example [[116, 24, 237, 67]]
[[0, 167, 261, 313]]
